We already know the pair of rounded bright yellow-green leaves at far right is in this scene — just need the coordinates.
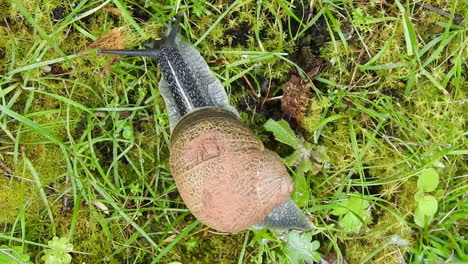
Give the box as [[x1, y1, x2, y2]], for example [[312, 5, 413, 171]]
[[414, 168, 439, 227]]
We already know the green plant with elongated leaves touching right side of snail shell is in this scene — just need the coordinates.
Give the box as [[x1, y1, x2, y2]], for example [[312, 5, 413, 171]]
[[264, 119, 329, 206]]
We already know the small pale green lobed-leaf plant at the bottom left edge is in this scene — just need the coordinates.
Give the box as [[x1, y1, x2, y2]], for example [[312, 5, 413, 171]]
[[41, 237, 73, 264]]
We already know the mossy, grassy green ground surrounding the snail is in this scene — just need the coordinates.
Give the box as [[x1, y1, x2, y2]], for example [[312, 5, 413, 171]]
[[0, 0, 468, 263]]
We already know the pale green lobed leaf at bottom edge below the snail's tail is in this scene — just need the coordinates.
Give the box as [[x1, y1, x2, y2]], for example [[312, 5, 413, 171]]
[[285, 232, 321, 264]]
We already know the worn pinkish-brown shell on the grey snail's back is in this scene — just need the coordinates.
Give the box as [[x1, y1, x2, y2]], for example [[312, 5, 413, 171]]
[[169, 107, 293, 232]]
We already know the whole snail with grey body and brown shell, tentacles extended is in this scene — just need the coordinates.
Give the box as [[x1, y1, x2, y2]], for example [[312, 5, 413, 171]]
[[99, 15, 311, 233]]
